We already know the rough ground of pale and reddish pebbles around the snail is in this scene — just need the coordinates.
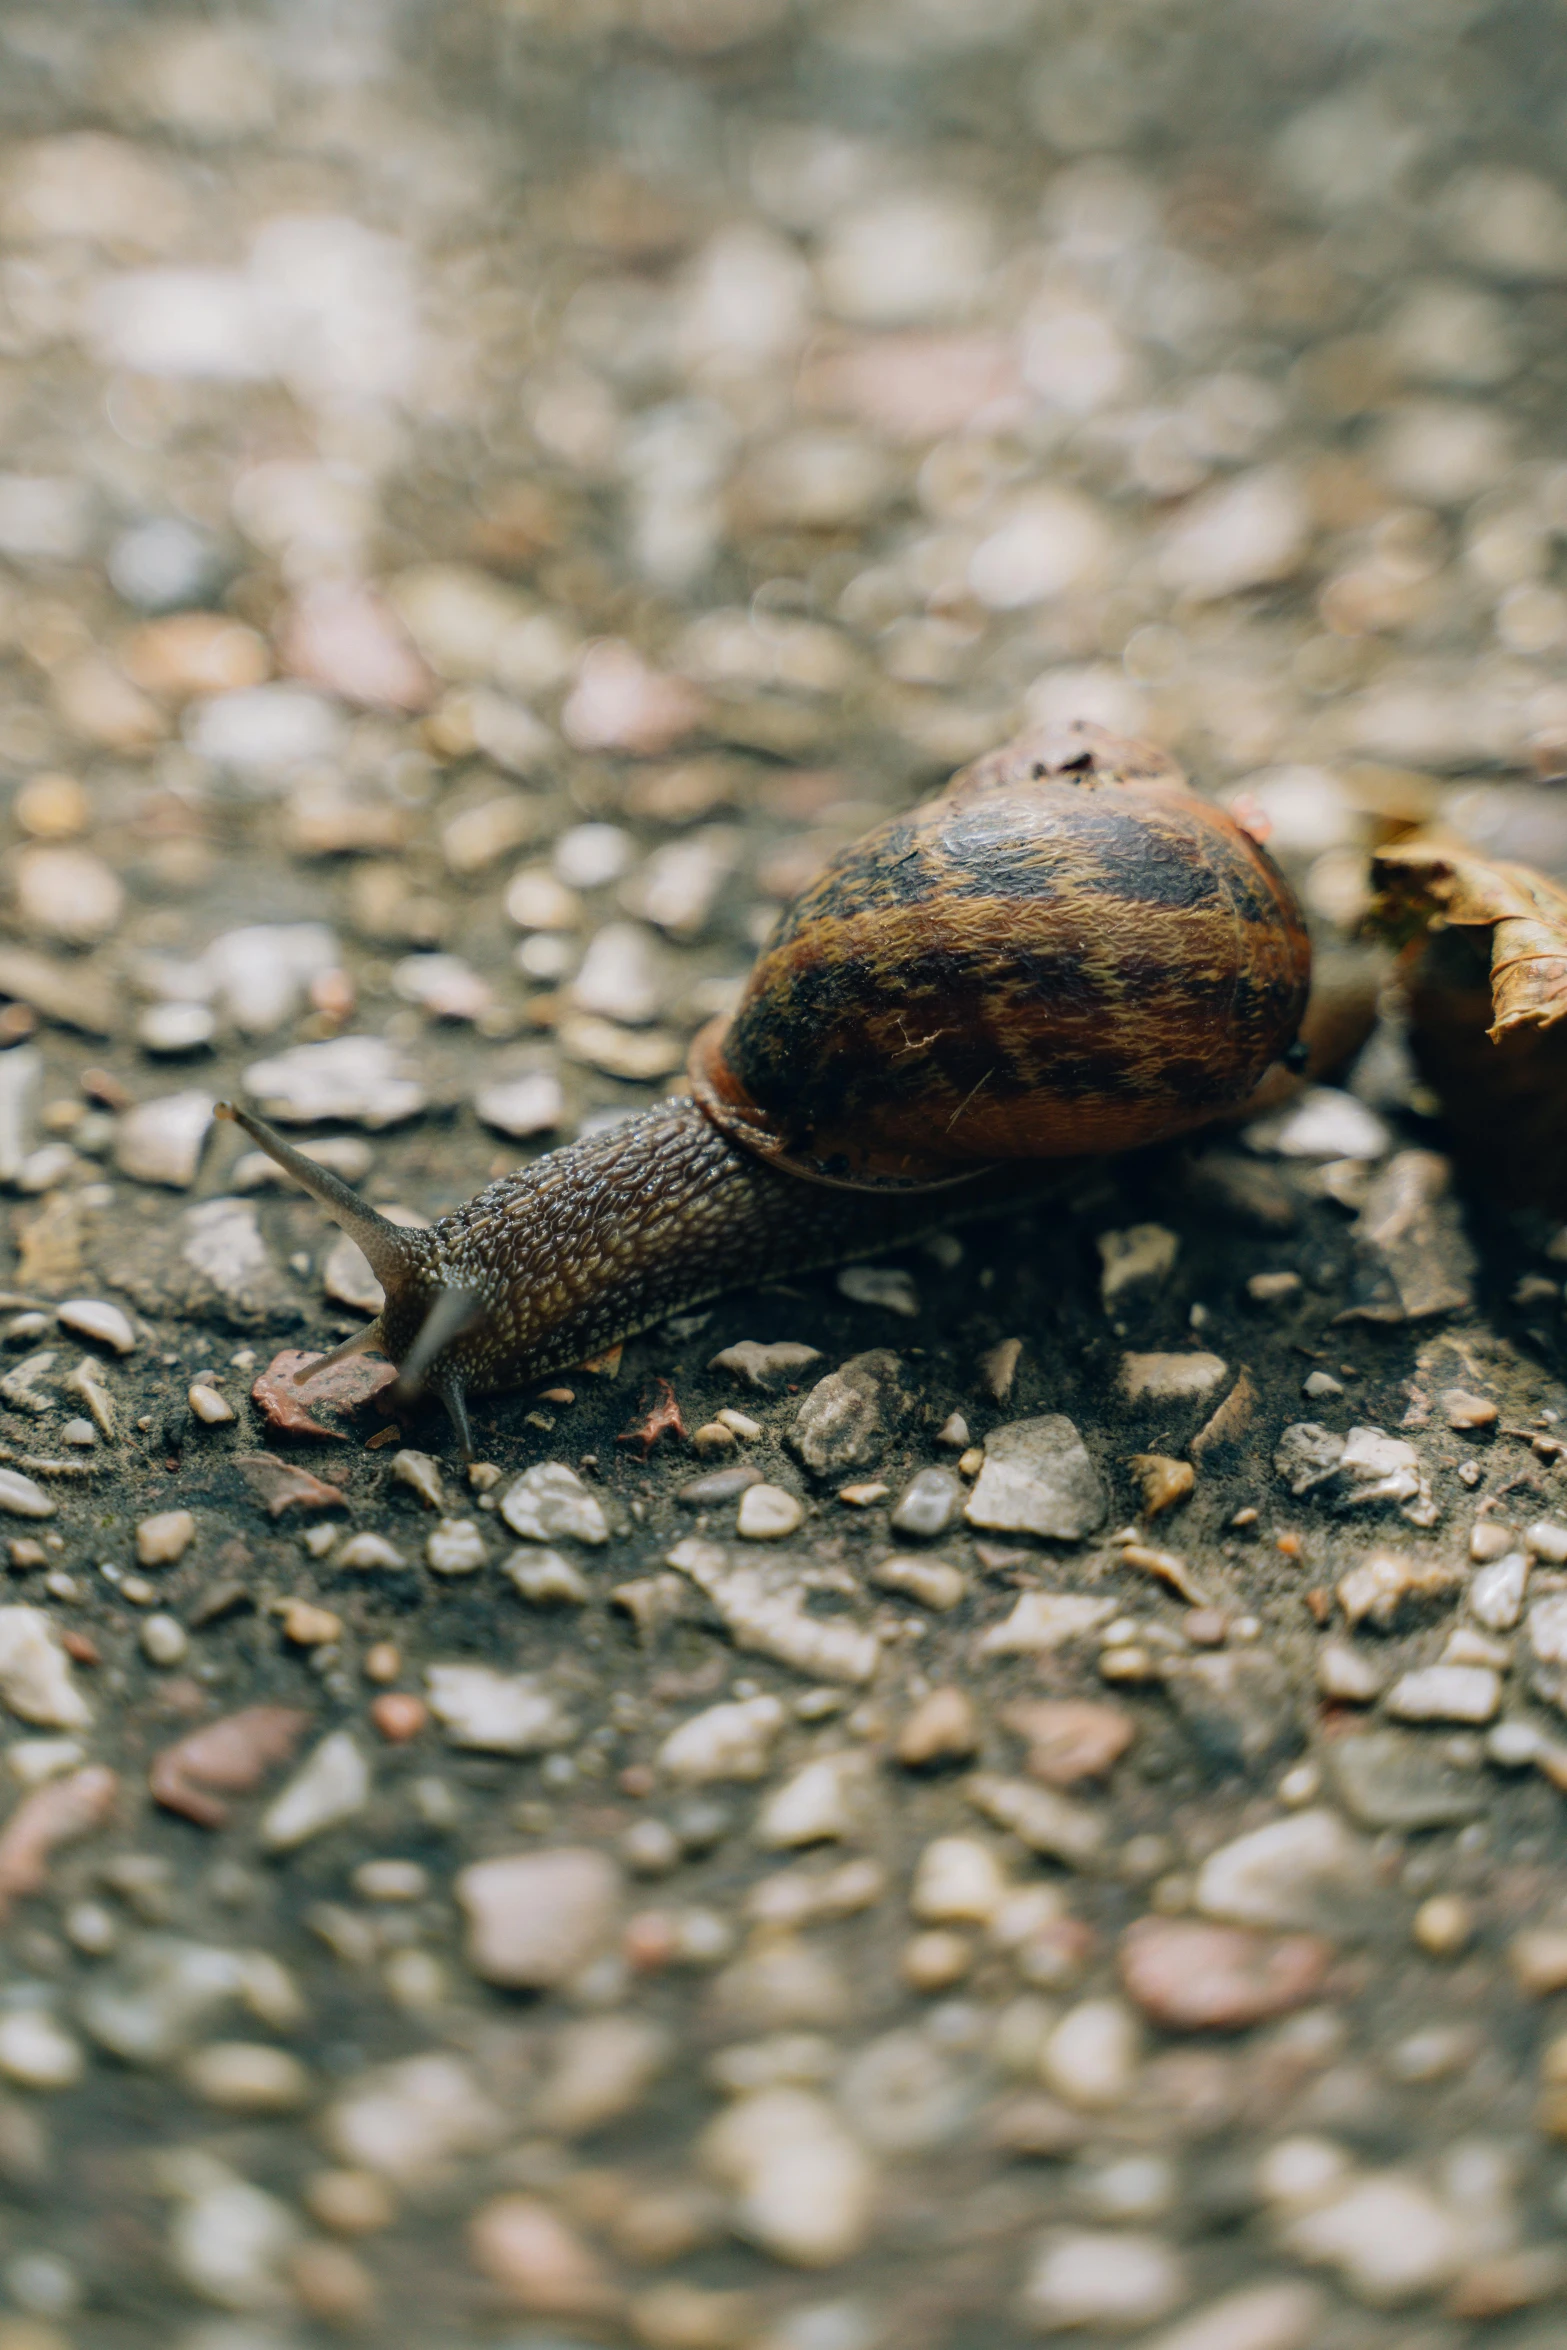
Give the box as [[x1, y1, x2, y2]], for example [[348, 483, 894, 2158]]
[[0, 0, 1567, 2350]]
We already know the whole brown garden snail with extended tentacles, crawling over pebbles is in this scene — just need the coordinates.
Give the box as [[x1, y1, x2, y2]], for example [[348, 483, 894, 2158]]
[[221, 724, 1311, 1457]]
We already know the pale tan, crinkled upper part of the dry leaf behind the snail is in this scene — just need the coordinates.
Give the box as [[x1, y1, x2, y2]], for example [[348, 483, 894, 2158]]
[[1372, 832, 1567, 1041]]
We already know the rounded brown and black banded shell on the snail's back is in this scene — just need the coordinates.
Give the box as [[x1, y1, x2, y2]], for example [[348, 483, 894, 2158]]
[[691, 729, 1311, 1184]]
